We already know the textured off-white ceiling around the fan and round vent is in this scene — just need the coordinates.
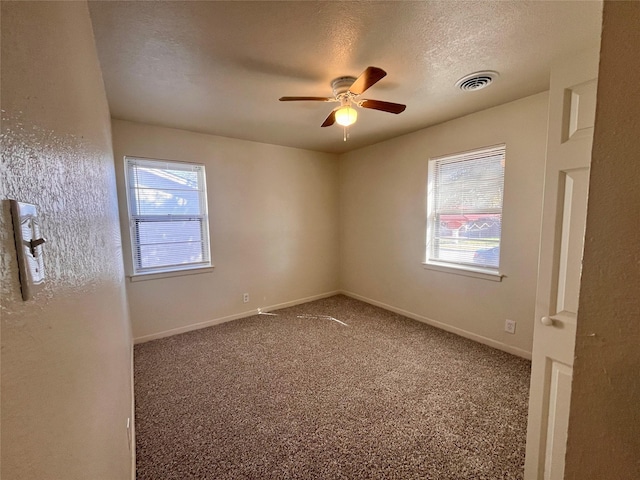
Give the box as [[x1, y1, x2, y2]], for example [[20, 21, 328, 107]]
[[90, 1, 602, 152]]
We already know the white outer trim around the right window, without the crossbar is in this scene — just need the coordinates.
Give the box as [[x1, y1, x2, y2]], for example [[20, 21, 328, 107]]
[[422, 143, 507, 282]]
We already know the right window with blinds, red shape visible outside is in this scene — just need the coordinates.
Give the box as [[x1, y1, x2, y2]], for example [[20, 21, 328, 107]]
[[426, 145, 505, 274]]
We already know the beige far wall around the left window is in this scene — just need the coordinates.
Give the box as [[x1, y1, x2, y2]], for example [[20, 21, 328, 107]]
[[113, 120, 338, 341]]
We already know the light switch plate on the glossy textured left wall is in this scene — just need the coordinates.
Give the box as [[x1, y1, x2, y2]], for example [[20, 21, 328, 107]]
[[9, 200, 45, 300]]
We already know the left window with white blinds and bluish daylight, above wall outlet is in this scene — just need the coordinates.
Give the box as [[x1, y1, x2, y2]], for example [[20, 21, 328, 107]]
[[125, 157, 211, 275]]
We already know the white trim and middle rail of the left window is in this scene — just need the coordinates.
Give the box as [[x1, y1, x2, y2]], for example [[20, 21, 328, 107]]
[[124, 156, 213, 282]]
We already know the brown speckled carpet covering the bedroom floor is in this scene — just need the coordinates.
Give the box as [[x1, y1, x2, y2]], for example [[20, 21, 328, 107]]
[[135, 295, 530, 480]]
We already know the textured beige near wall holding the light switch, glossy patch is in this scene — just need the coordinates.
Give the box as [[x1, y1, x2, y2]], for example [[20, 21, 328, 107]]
[[0, 2, 132, 480]]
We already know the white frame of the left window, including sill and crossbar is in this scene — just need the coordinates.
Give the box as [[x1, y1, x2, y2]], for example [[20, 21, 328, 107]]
[[124, 156, 213, 281]]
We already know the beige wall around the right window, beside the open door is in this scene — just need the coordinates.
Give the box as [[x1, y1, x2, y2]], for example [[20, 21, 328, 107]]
[[340, 93, 548, 357]]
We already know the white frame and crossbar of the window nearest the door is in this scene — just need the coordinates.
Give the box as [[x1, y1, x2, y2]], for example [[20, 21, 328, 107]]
[[422, 144, 506, 281]]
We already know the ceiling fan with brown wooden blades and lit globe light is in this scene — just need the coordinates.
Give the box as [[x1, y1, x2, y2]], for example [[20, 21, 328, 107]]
[[280, 67, 407, 133]]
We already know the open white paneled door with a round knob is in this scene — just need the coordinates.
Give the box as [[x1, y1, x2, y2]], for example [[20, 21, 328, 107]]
[[524, 46, 599, 480]]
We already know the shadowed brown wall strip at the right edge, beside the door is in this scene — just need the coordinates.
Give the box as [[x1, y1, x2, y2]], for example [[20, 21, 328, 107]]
[[565, 1, 640, 480]]
